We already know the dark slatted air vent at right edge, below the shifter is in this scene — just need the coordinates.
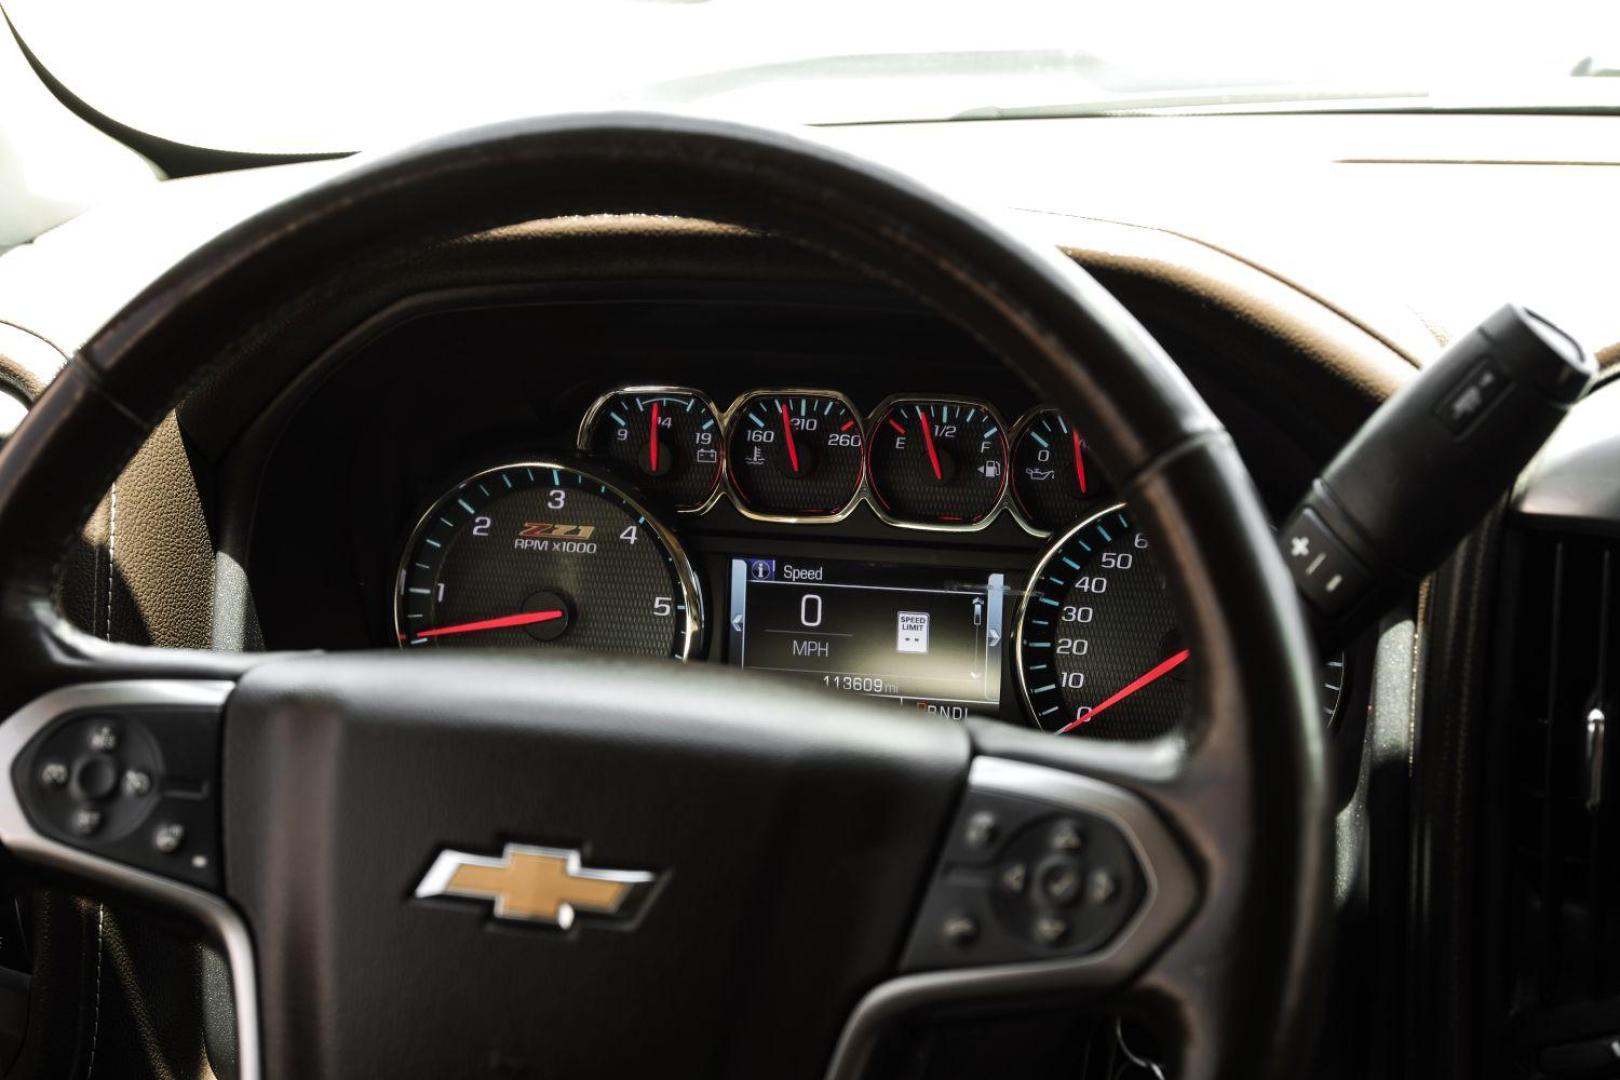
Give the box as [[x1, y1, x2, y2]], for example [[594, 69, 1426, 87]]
[[1497, 533, 1620, 1075]]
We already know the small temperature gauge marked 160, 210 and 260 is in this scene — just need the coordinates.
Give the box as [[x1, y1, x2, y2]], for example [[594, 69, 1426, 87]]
[[726, 390, 865, 521]]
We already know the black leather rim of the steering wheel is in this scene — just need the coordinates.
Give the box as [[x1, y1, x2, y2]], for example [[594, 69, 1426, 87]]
[[0, 113, 1332, 1077]]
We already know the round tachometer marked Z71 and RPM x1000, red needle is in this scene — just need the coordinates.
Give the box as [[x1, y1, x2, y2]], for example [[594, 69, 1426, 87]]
[[394, 461, 703, 659]]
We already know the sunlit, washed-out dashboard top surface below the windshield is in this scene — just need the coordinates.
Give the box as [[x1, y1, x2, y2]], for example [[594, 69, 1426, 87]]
[[0, 113, 1620, 375]]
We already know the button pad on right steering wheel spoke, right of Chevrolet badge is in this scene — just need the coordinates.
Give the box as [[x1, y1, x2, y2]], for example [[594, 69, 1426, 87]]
[[902, 792, 1147, 972]]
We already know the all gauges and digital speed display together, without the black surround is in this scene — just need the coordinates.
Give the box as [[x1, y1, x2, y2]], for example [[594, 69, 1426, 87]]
[[394, 385, 1345, 740]]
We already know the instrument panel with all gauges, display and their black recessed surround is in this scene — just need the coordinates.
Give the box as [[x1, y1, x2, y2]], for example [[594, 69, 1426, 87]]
[[236, 288, 1349, 738]]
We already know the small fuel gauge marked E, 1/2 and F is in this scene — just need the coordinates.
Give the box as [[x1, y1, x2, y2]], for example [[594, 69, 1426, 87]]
[[870, 398, 1008, 529]]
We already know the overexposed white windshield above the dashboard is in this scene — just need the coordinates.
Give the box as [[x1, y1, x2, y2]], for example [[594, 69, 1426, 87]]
[[5, 0, 1620, 152]]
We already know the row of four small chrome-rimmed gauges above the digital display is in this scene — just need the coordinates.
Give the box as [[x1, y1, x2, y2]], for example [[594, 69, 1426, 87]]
[[578, 385, 1115, 536]]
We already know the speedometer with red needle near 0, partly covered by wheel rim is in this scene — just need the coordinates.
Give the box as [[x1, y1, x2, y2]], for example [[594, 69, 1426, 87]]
[[1014, 505, 1345, 738]]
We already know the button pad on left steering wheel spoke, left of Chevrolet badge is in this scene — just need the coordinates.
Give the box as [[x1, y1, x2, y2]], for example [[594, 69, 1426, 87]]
[[11, 706, 220, 889]]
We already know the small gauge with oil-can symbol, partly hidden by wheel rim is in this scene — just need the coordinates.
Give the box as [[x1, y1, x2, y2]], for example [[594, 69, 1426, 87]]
[[1013, 408, 1115, 533]]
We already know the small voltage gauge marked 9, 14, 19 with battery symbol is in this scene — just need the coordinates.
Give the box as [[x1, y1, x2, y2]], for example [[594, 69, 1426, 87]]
[[580, 387, 724, 512]]
